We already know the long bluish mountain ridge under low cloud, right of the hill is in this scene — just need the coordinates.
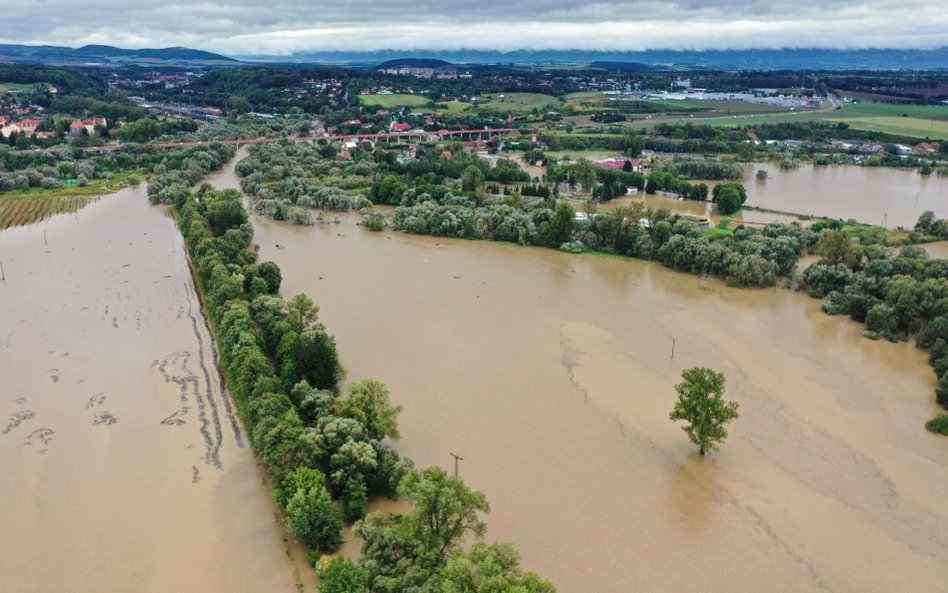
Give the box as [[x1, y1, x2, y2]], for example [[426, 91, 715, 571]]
[[237, 47, 948, 70]]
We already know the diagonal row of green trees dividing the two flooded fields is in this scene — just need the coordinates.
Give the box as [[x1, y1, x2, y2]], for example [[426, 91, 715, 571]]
[[176, 185, 555, 593]]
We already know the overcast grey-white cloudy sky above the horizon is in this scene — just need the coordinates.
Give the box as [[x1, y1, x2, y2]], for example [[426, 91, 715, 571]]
[[0, 0, 948, 55]]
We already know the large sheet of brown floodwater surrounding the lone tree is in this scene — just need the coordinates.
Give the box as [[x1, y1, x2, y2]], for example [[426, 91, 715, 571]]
[[206, 148, 948, 593]]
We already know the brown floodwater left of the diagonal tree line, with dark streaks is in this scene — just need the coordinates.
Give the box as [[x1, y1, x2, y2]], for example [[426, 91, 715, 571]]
[[0, 185, 312, 593]]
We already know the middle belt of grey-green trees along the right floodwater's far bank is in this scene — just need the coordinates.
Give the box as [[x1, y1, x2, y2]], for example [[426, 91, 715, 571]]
[[393, 189, 817, 286]]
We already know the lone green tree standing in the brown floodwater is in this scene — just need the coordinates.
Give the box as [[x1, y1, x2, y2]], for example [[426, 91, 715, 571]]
[[668, 367, 739, 455]]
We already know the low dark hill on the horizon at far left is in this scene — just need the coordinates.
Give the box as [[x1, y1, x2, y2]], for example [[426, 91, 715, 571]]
[[0, 45, 239, 66]]
